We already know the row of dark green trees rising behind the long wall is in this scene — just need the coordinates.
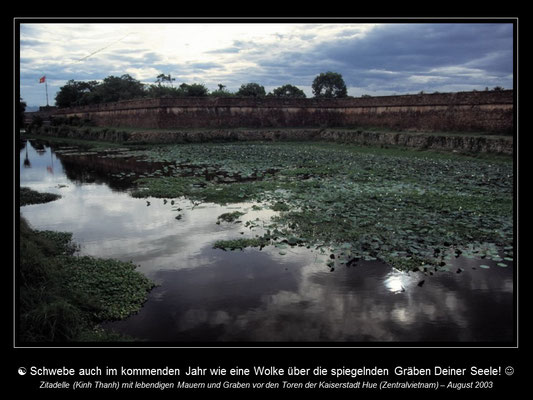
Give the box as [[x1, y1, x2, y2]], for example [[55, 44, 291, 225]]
[[55, 71, 348, 108]]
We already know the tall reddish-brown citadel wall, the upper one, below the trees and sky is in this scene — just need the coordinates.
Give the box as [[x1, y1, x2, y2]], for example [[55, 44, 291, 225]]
[[56, 90, 514, 133]]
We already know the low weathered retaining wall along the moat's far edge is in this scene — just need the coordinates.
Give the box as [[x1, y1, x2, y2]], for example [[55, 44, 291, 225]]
[[29, 125, 513, 155]]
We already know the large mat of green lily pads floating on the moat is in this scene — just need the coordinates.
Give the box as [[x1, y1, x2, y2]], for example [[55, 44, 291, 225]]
[[124, 142, 513, 269]]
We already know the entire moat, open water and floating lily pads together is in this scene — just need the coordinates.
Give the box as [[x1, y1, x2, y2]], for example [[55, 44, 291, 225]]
[[20, 140, 514, 345]]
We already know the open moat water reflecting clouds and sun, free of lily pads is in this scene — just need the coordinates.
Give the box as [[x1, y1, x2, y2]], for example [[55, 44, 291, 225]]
[[20, 142, 515, 345]]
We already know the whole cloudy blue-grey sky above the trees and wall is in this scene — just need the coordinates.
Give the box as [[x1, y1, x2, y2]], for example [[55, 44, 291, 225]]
[[20, 21, 513, 106]]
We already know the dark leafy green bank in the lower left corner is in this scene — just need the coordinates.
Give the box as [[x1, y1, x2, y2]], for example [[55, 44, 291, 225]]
[[18, 214, 153, 343]]
